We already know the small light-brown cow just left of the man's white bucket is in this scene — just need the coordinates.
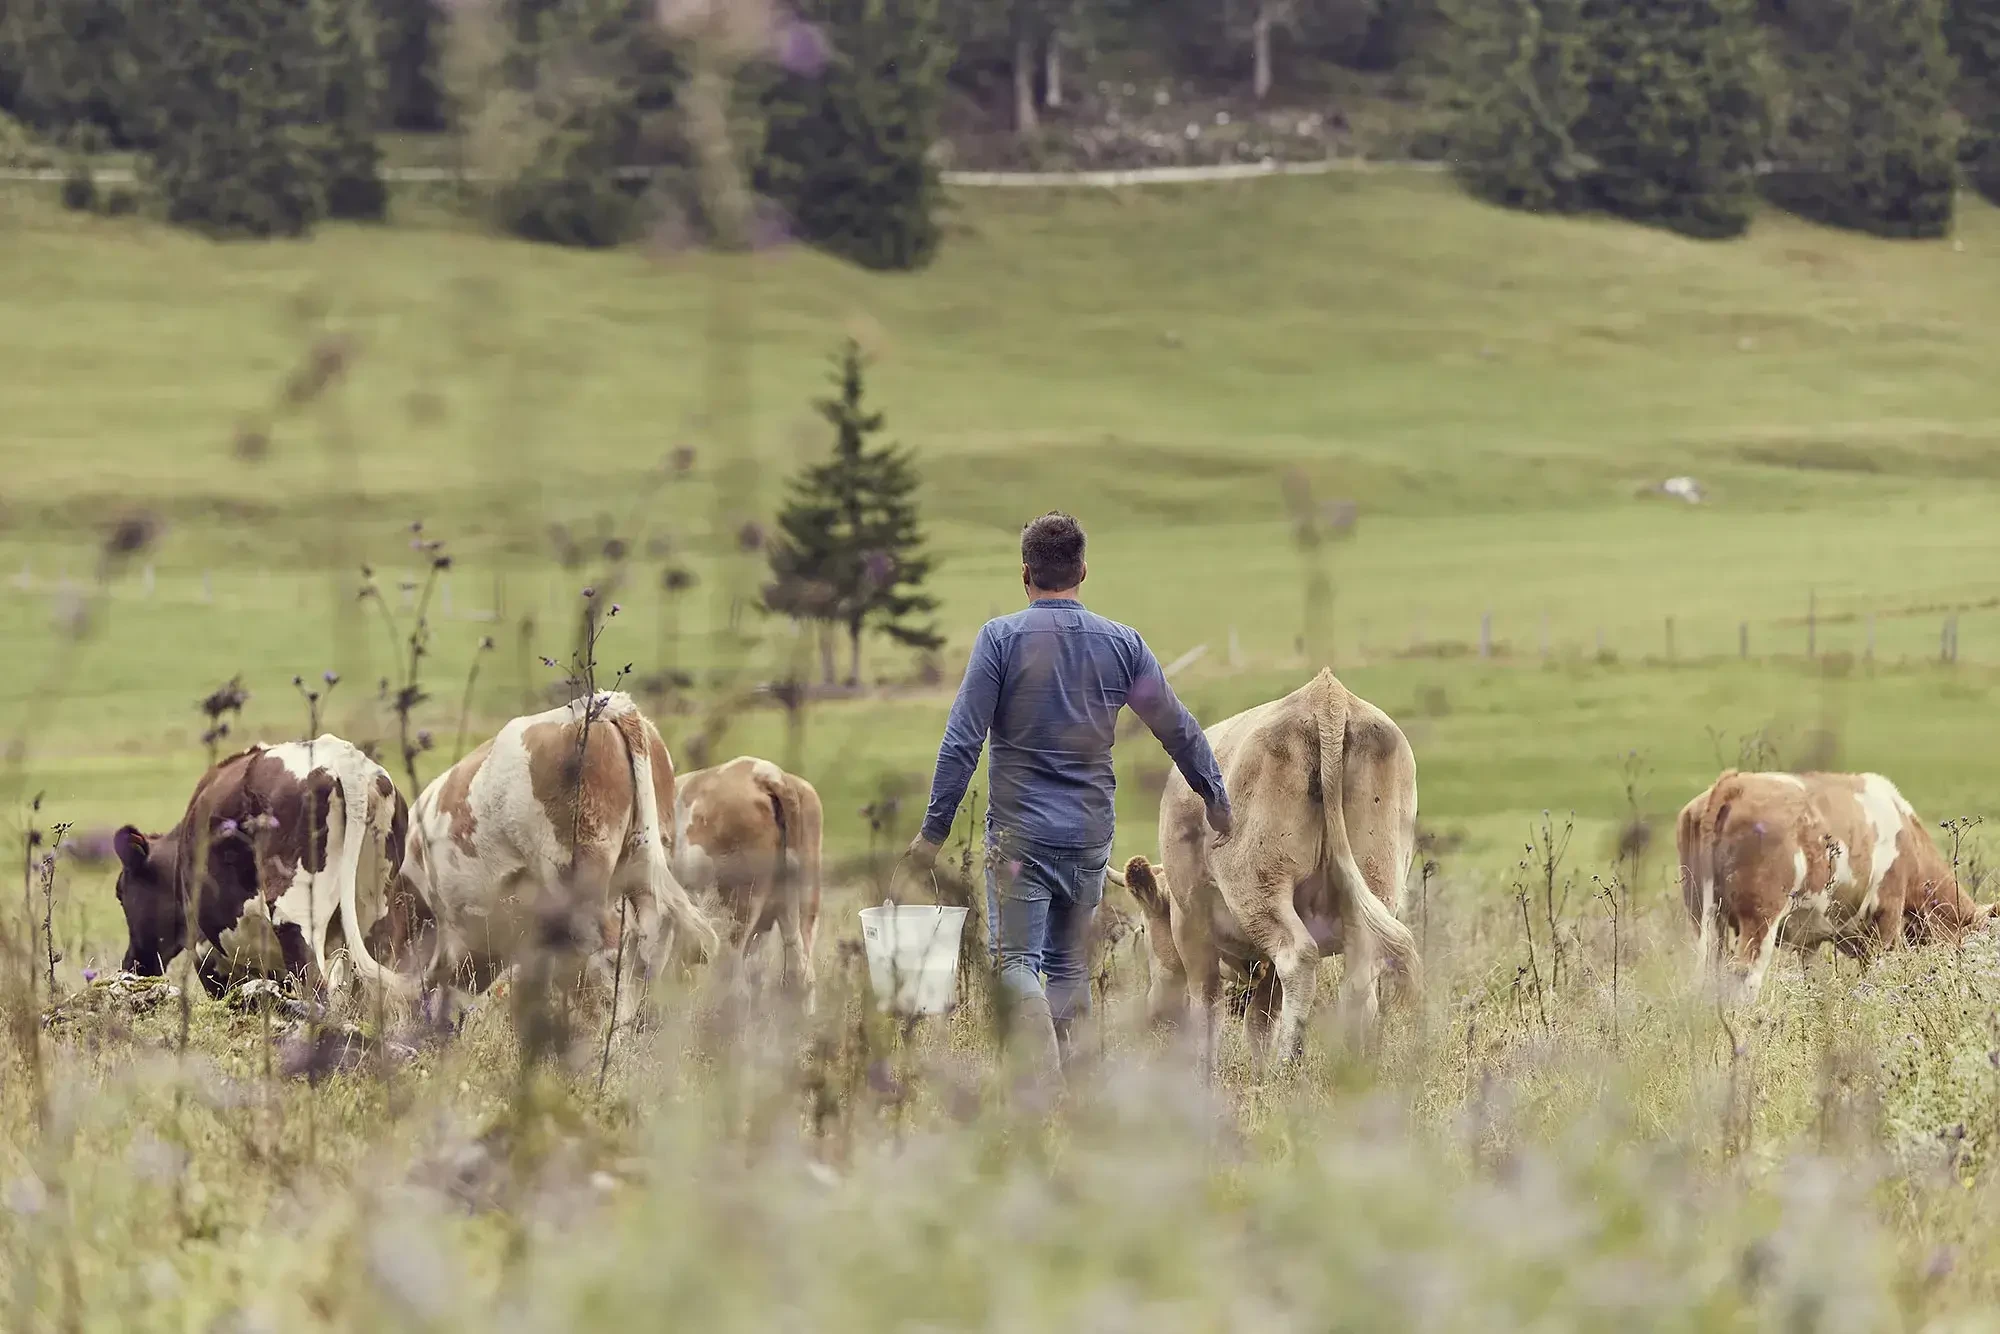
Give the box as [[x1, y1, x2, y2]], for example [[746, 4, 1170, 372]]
[[674, 756, 820, 1014]]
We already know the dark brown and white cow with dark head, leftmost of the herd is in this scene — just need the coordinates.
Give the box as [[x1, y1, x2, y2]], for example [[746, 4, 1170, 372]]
[[112, 734, 410, 994]]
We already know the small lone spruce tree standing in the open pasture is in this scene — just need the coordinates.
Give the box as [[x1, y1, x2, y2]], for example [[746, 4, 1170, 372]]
[[764, 338, 944, 686]]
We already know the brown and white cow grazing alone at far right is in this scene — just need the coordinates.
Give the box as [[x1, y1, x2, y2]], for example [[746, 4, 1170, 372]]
[[1674, 770, 1994, 1002]]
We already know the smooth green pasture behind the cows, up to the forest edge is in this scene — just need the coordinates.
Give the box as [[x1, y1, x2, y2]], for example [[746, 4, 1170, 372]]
[[0, 172, 2000, 948]]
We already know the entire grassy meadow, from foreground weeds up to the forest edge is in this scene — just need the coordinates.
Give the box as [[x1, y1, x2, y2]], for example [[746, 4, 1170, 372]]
[[0, 172, 2000, 1330]]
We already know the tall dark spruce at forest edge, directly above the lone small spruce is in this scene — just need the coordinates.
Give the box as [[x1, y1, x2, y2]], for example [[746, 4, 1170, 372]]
[[756, 0, 952, 268]]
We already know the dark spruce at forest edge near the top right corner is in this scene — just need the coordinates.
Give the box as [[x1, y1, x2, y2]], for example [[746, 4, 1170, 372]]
[[1766, 0, 1958, 238]]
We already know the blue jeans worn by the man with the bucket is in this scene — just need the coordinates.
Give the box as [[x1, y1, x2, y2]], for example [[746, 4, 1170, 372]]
[[986, 834, 1112, 1024]]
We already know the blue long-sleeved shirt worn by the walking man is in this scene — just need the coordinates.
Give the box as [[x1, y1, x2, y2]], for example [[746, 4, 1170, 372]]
[[924, 598, 1228, 848]]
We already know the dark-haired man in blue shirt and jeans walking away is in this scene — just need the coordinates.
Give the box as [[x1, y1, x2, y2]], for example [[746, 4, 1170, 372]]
[[908, 512, 1230, 1072]]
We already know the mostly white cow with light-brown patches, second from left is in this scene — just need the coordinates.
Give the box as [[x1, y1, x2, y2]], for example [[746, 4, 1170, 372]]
[[404, 692, 718, 1022]]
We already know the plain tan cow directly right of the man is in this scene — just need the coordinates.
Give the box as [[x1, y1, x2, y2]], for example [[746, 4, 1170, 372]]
[[1124, 670, 1422, 1070]]
